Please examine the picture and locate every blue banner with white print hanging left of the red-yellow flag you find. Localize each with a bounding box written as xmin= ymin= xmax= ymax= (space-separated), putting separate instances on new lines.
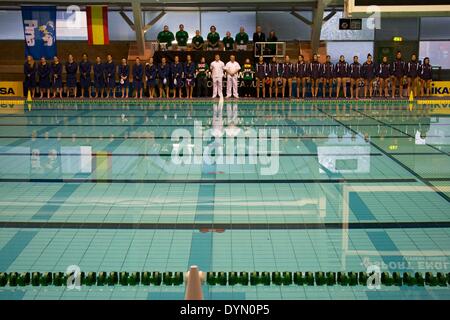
xmin=22 ymin=6 xmax=56 ymax=59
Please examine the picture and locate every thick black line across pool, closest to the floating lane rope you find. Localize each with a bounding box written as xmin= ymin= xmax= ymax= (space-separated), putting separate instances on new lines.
xmin=0 ymin=221 xmax=450 ymax=231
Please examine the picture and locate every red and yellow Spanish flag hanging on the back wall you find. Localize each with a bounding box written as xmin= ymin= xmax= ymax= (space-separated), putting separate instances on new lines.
xmin=86 ymin=6 xmax=109 ymax=45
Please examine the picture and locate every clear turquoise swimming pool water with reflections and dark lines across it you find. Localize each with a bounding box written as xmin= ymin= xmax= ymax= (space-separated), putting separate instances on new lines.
xmin=0 ymin=100 xmax=450 ymax=299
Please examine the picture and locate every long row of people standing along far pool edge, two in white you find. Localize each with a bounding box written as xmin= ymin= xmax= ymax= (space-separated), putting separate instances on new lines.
xmin=24 ymin=51 xmax=432 ymax=99
